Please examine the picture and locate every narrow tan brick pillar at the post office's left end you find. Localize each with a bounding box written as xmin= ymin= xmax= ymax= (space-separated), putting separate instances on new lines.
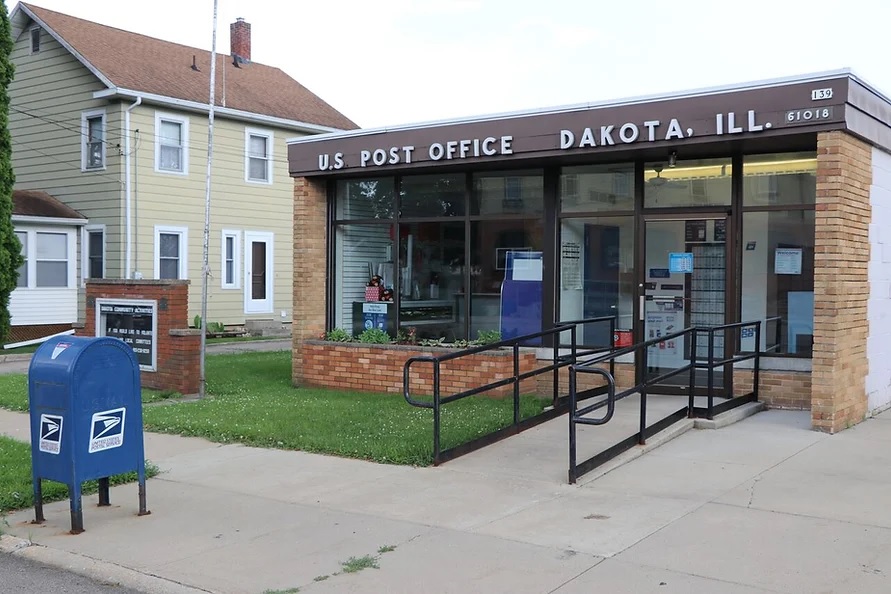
xmin=291 ymin=178 xmax=328 ymax=386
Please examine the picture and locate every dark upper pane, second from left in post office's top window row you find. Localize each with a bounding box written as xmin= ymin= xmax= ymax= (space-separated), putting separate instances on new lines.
xmin=399 ymin=173 xmax=467 ymax=218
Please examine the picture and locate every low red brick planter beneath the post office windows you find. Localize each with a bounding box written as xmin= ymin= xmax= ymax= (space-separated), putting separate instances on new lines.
xmin=302 ymin=340 xmax=538 ymax=396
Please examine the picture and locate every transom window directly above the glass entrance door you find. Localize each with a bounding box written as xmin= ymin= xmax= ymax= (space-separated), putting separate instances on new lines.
xmin=644 ymin=159 xmax=732 ymax=208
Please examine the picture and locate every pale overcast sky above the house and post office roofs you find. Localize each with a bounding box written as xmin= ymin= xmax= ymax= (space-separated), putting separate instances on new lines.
xmin=12 ymin=0 xmax=891 ymax=128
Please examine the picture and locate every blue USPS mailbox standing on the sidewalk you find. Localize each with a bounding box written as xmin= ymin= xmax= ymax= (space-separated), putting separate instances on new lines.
xmin=28 ymin=336 xmax=149 ymax=534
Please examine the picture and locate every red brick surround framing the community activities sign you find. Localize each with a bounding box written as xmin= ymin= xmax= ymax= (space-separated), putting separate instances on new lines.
xmin=77 ymin=279 xmax=201 ymax=394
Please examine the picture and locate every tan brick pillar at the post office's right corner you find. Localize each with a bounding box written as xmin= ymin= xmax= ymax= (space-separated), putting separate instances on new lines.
xmin=811 ymin=131 xmax=872 ymax=433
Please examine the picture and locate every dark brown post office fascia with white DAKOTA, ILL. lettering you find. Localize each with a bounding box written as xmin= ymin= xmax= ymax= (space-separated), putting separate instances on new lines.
xmin=288 ymin=69 xmax=891 ymax=177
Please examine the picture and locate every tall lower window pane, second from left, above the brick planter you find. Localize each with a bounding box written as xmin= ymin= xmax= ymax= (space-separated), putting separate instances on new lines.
xmin=398 ymin=221 xmax=465 ymax=342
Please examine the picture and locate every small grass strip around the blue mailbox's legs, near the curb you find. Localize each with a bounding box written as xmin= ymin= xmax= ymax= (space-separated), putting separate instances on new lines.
xmin=0 ymin=435 xmax=158 ymax=516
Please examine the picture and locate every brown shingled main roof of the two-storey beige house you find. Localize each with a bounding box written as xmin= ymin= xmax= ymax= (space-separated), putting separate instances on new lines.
xmin=19 ymin=3 xmax=358 ymax=130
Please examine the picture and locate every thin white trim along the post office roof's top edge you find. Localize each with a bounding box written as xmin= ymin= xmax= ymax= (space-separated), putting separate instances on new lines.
xmin=290 ymin=68 xmax=863 ymax=145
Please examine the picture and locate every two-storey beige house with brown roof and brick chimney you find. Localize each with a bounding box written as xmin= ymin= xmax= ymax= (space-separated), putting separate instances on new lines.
xmin=9 ymin=3 xmax=356 ymax=338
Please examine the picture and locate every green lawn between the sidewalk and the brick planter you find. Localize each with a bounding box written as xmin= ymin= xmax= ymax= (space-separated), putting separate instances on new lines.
xmin=0 ymin=351 xmax=550 ymax=465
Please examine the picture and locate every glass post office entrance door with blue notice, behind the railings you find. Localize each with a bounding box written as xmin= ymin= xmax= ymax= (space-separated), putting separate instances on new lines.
xmin=638 ymin=215 xmax=733 ymax=393
